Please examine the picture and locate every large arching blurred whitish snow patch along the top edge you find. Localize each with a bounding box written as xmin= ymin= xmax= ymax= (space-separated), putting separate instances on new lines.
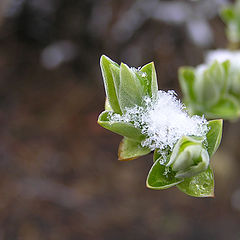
xmin=112 ymin=0 xmax=229 ymax=47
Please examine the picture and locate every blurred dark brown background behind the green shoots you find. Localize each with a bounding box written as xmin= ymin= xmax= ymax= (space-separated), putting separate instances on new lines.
xmin=0 ymin=0 xmax=240 ymax=240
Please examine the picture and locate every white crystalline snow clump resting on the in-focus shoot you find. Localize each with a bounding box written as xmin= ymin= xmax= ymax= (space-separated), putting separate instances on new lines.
xmin=109 ymin=91 xmax=208 ymax=150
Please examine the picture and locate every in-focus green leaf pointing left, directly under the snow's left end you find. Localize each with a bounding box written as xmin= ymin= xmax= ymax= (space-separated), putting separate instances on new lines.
xmin=98 ymin=111 xmax=145 ymax=142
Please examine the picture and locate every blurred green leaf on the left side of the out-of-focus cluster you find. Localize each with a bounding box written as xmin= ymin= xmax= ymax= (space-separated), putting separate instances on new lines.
xmin=178 ymin=67 xmax=196 ymax=102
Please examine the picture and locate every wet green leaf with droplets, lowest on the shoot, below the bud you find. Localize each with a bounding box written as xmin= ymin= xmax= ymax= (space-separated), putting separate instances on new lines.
xmin=177 ymin=167 xmax=214 ymax=197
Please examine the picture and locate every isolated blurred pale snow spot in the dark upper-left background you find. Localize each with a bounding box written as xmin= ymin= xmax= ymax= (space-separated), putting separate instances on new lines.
xmin=40 ymin=40 xmax=77 ymax=69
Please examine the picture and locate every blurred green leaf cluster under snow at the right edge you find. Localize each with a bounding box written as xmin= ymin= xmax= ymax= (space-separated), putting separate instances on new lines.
xmin=178 ymin=61 xmax=240 ymax=119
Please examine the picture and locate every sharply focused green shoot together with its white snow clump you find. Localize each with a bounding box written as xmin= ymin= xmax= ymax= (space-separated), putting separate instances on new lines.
xmin=98 ymin=56 xmax=222 ymax=197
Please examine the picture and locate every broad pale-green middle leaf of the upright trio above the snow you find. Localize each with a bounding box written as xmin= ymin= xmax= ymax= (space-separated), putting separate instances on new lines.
xmin=119 ymin=63 xmax=144 ymax=112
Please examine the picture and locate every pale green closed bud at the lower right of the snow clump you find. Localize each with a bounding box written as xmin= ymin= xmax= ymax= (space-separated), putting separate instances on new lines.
xmin=166 ymin=136 xmax=209 ymax=178
